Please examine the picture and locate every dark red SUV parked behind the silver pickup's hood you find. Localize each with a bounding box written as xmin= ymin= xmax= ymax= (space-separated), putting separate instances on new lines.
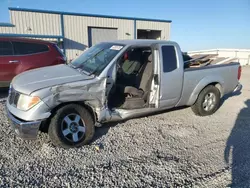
xmin=0 ymin=37 xmax=66 ymax=87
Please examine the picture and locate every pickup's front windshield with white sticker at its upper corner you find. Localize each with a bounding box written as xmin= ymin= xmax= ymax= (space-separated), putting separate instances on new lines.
xmin=71 ymin=43 xmax=124 ymax=75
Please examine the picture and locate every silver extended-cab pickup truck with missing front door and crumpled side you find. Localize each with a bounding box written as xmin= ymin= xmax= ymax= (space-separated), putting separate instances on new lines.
xmin=6 ymin=40 xmax=241 ymax=148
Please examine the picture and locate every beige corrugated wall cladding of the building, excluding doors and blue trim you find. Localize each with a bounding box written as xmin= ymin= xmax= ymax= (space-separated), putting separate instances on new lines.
xmin=0 ymin=10 xmax=170 ymax=59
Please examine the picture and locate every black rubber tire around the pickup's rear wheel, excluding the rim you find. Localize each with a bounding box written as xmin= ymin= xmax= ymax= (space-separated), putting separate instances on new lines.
xmin=191 ymin=85 xmax=220 ymax=116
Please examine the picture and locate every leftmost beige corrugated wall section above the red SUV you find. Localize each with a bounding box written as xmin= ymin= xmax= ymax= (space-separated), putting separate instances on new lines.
xmin=0 ymin=11 xmax=61 ymax=35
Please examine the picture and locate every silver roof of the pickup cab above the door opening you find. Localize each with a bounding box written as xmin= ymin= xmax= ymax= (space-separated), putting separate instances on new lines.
xmin=109 ymin=39 xmax=177 ymax=45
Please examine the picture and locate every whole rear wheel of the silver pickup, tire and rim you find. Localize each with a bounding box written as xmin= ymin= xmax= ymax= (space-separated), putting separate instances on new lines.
xmin=191 ymin=85 xmax=220 ymax=116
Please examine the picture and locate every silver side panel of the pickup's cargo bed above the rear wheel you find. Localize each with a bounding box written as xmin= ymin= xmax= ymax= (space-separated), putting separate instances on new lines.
xmin=177 ymin=64 xmax=239 ymax=106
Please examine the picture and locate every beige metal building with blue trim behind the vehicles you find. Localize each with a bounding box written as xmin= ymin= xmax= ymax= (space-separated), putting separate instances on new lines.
xmin=0 ymin=8 xmax=171 ymax=59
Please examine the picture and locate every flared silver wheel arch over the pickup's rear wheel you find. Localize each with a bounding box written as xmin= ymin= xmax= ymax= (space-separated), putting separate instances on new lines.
xmin=187 ymin=76 xmax=224 ymax=106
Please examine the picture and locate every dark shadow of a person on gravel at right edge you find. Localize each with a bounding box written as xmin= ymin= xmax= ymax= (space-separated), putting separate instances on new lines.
xmin=224 ymin=99 xmax=250 ymax=187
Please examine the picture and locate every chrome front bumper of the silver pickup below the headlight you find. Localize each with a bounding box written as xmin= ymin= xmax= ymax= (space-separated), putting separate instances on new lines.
xmin=6 ymin=109 xmax=42 ymax=140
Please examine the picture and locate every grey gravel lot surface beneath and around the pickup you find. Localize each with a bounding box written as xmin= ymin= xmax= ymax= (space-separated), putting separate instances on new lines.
xmin=0 ymin=67 xmax=250 ymax=187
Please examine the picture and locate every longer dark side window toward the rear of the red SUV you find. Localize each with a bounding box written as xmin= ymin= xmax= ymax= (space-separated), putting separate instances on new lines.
xmin=12 ymin=41 xmax=49 ymax=55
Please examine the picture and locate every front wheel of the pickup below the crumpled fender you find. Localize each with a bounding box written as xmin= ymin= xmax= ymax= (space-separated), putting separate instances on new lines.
xmin=48 ymin=104 xmax=95 ymax=148
